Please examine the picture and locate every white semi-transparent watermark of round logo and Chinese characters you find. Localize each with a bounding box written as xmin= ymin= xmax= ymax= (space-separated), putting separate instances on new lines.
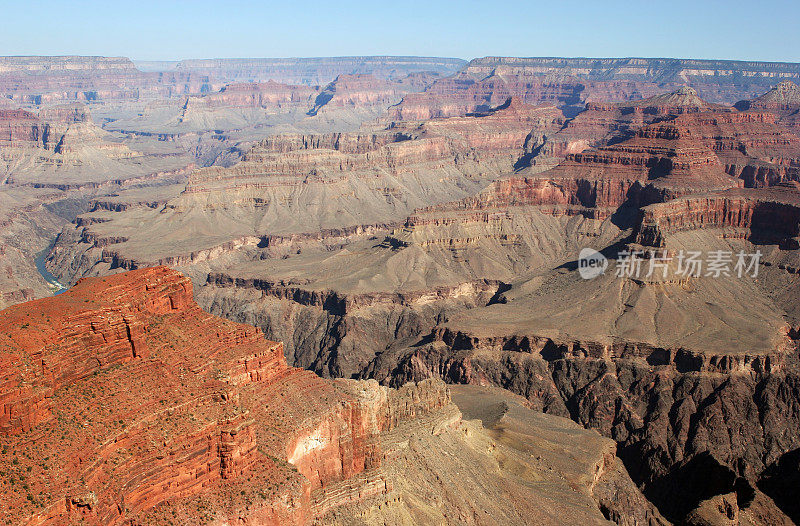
xmin=578 ymin=248 xmax=762 ymax=279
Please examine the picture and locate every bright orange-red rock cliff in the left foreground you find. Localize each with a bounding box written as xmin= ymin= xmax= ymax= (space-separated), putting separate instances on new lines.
xmin=0 ymin=267 xmax=449 ymax=524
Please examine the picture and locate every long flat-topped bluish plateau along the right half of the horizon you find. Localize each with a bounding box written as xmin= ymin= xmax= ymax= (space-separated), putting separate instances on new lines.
xmin=392 ymin=57 xmax=800 ymax=119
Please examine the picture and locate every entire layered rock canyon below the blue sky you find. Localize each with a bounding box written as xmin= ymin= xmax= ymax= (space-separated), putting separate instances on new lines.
xmin=0 ymin=52 xmax=800 ymax=525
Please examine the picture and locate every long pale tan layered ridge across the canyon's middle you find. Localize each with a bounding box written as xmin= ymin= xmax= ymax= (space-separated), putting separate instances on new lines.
xmin=48 ymin=97 xmax=561 ymax=274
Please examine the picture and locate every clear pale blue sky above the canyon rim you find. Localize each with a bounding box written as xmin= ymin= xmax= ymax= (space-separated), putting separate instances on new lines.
xmin=0 ymin=0 xmax=800 ymax=62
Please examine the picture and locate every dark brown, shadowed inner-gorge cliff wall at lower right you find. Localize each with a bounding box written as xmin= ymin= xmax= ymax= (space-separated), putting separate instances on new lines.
xmin=376 ymin=332 xmax=800 ymax=524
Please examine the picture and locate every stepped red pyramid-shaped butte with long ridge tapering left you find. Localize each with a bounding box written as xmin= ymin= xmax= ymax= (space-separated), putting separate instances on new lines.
xmin=409 ymin=113 xmax=741 ymax=224
